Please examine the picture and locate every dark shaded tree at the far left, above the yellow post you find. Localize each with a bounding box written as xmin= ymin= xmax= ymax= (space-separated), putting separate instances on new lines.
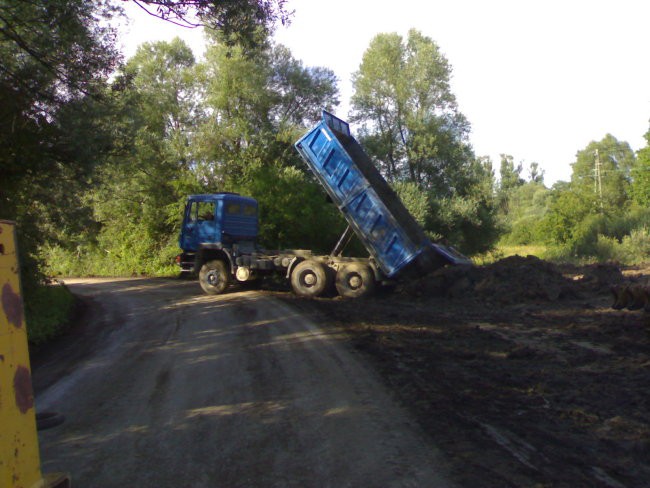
xmin=0 ymin=0 xmax=119 ymax=285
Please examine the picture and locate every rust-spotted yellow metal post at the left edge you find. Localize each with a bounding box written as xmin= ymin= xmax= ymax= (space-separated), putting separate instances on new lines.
xmin=0 ymin=220 xmax=69 ymax=488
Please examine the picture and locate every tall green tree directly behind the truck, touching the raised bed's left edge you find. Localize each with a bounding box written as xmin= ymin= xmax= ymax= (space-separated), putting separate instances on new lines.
xmin=195 ymin=36 xmax=340 ymax=249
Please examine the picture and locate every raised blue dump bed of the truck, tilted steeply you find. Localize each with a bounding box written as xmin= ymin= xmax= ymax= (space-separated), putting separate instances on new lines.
xmin=296 ymin=111 xmax=470 ymax=278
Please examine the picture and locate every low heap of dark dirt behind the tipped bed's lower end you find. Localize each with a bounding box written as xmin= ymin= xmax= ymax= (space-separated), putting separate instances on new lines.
xmin=398 ymin=256 xmax=622 ymax=304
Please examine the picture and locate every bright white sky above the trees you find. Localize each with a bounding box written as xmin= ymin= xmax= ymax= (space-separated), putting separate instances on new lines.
xmin=122 ymin=0 xmax=650 ymax=185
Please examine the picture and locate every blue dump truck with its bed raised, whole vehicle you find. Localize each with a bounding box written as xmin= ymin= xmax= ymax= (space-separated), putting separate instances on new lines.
xmin=176 ymin=111 xmax=470 ymax=297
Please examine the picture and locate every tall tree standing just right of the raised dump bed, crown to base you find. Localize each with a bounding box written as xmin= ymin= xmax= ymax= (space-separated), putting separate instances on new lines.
xmin=351 ymin=30 xmax=496 ymax=252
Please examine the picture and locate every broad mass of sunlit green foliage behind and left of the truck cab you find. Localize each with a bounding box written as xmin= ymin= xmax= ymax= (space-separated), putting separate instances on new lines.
xmin=48 ymin=34 xmax=340 ymax=274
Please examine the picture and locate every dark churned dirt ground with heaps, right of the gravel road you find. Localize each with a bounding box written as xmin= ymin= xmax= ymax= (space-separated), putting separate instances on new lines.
xmin=274 ymin=256 xmax=650 ymax=488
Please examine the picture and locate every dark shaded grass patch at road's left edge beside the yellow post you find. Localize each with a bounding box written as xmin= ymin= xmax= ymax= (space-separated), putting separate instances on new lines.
xmin=24 ymin=283 xmax=75 ymax=345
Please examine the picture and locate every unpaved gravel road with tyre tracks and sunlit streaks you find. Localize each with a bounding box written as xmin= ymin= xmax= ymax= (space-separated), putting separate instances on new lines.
xmin=32 ymin=279 xmax=450 ymax=488
